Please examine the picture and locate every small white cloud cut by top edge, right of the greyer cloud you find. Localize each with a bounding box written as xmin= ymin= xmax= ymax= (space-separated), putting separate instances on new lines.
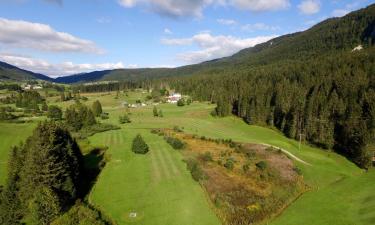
xmin=229 ymin=0 xmax=290 ymax=11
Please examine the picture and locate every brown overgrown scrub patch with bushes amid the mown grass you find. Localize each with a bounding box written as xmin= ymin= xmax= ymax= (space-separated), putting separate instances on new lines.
xmin=157 ymin=129 xmax=305 ymax=225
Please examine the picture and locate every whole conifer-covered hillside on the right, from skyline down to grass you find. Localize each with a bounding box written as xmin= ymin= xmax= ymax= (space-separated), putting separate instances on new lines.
xmin=160 ymin=5 xmax=375 ymax=168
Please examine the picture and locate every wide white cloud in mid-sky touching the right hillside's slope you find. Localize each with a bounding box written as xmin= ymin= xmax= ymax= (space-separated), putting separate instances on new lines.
xmin=162 ymin=33 xmax=277 ymax=63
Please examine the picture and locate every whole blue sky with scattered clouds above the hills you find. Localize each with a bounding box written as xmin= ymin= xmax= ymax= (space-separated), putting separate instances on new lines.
xmin=0 ymin=0 xmax=374 ymax=76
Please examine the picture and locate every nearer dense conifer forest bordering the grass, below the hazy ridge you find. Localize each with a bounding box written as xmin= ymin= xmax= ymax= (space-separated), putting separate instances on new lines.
xmin=167 ymin=47 xmax=375 ymax=168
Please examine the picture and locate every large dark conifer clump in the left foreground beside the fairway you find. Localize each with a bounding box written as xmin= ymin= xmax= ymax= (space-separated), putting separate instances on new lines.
xmin=0 ymin=121 xmax=83 ymax=224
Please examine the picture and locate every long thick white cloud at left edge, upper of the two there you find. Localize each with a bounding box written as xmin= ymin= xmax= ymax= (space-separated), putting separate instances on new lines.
xmin=0 ymin=18 xmax=103 ymax=54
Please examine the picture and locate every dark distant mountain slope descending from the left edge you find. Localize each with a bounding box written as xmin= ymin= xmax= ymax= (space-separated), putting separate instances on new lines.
xmin=0 ymin=62 xmax=54 ymax=81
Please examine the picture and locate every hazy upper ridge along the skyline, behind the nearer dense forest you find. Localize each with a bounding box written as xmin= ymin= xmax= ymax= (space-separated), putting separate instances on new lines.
xmin=58 ymin=4 xmax=375 ymax=83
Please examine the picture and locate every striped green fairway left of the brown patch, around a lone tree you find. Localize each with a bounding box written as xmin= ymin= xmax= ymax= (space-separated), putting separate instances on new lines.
xmin=90 ymin=129 xmax=220 ymax=225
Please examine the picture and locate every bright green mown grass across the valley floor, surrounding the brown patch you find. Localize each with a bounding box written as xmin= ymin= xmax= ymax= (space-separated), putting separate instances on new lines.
xmin=0 ymin=92 xmax=375 ymax=225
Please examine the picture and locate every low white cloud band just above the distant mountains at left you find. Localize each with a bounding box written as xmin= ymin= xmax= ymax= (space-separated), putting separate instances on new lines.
xmin=0 ymin=53 xmax=126 ymax=77
